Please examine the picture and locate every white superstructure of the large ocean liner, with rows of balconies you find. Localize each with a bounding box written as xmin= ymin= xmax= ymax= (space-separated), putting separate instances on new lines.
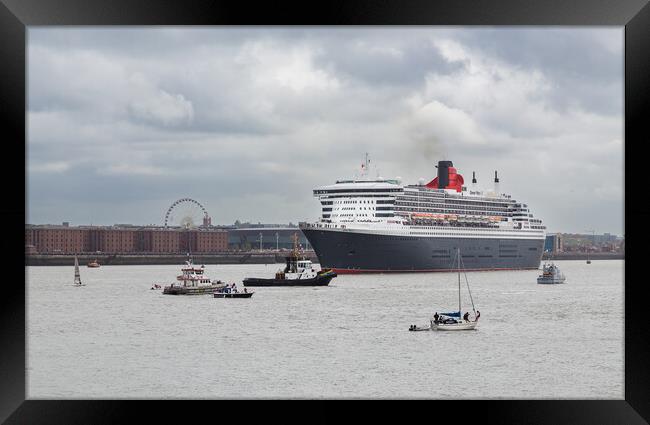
xmin=304 ymin=176 xmax=546 ymax=238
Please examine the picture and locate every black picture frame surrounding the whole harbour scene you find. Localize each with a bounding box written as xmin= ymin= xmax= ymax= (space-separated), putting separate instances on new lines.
xmin=0 ymin=0 xmax=650 ymax=424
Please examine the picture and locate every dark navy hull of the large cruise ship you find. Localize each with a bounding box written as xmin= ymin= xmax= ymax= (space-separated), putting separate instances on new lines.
xmin=302 ymin=228 xmax=544 ymax=273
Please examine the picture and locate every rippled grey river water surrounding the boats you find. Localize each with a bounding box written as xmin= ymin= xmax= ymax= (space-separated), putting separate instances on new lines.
xmin=26 ymin=260 xmax=624 ymax=399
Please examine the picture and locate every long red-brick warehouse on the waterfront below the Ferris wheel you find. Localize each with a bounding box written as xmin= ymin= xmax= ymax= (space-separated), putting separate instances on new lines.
xmin=25 ymin=223 xmax=228 ymax=254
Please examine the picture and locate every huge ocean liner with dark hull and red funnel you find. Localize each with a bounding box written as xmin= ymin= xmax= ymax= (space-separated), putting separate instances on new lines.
xmin=300 ymin=157 xmax=546 ymax=273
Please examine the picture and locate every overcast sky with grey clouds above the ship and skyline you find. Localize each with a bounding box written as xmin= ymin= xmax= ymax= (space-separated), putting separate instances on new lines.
xmin=26 ymin=27 xmax=624 ymax=235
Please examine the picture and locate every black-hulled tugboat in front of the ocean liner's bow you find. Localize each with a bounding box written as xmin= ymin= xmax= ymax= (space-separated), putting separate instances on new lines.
xmin=243 ymin=233 xmax=336 ymax=286
